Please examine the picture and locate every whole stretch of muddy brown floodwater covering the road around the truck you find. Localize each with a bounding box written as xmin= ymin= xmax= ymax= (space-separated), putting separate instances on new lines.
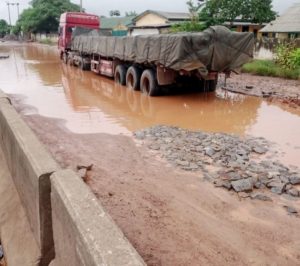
xmin=0 ymin=43 xmax=300 ymax=166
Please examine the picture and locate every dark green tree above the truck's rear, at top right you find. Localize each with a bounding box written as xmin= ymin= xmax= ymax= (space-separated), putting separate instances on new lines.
xmin=199 ymin=0 xmax=276 ymax=26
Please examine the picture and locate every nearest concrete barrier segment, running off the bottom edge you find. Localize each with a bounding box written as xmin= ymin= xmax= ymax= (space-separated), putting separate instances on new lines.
xmin=51 ymin=170 xmax=145 ymax=266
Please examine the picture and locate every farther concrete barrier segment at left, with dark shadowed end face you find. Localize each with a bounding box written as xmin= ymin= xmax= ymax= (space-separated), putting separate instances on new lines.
xmin=0 ymin=94 xmax=59 ymax=265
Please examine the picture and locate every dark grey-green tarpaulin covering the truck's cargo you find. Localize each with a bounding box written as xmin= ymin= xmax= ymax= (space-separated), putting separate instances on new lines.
xmin=71 ymin=26 xmax=254 ymax=72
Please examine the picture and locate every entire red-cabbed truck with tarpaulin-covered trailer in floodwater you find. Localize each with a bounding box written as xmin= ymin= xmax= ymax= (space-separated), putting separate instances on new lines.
xmin=58 ymin=12 xmax=254 ymax=96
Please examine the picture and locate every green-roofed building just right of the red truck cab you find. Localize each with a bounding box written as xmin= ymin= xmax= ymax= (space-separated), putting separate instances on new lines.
xmin=100 ymin=16 xmax=135 ymax=36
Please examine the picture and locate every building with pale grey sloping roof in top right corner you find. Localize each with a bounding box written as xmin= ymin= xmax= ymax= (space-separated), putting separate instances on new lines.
xmin=260 ymin=3 xmax=300 ymax=39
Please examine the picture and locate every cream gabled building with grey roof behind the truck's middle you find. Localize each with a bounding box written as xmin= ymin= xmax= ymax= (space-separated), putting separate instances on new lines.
xmin=129 ymin=10 xmax=191 ymax=36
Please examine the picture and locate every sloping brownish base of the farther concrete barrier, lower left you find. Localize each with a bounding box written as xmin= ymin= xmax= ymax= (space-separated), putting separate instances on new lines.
xmin=0 ymin=144 xmax=41 ymax=266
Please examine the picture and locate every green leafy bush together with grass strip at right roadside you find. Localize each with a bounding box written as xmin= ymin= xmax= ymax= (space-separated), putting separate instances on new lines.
xmin=242 ymin=44 xmax=300 ymax=80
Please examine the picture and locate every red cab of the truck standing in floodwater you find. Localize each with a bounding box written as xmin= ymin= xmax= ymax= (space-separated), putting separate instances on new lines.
xmin=58 ymin=12 xmax=100 ymax=58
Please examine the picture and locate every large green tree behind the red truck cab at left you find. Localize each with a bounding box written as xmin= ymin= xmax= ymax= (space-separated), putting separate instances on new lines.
xmin=17 ymin=0 xmax=80 ymax=32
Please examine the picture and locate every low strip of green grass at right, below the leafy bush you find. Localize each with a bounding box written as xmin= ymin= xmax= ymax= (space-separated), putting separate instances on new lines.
xmin=242 ymin=60 xmax=300 ymax=79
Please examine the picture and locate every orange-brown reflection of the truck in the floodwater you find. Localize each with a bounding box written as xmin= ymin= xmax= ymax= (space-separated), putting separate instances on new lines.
xmin=62 ymin=65 xmax=261 ymax=134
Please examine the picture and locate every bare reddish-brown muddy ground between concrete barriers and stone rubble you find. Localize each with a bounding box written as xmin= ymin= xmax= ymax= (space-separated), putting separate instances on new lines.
xmin=11 ymin=92 xmax=300 ymax=266
